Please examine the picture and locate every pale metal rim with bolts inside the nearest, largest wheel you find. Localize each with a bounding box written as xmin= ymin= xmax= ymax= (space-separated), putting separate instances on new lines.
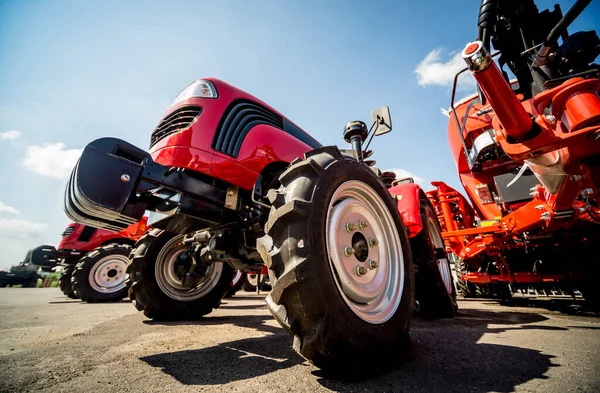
xmin=325 ymin=180 xmax=404 ymax=324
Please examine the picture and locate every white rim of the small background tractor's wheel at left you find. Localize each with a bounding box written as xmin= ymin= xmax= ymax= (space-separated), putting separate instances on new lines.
xmin=88 ymin=255 xmax=129 ymax=293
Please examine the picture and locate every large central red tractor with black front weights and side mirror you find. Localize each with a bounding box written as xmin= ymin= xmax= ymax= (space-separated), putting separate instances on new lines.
xmin=65 ymin=78 xmax=456 ymax=367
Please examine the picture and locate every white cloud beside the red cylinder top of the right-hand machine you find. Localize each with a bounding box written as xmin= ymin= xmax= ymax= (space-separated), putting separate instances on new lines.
xmin=415 ymin=48 xmax=476 ymax=90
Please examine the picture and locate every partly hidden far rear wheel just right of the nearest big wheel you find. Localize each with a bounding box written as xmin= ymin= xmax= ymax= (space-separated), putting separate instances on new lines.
xmin=410 ymin=199 xmax=458 ymax=318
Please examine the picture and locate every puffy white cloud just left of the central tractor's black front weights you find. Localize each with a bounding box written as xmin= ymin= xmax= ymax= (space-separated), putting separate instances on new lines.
xmin=23 ymin=143 xmax=83 ymax=179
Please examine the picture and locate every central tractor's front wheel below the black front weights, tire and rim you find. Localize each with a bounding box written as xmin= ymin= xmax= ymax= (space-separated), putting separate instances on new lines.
xmin=127 ymin=229 xmax=233 ymax=321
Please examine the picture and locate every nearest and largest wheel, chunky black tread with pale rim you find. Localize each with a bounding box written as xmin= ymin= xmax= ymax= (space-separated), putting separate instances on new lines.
xmin=258 ymin=147 xmax=414 ymax=374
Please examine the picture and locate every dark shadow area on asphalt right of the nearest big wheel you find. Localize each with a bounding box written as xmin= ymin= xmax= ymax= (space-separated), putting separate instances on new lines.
xmin=313 ymin=309 xmax=568 ymax=392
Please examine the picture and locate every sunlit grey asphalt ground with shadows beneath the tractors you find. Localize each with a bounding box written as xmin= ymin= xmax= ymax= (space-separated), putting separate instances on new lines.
xmin=0 ymin=288 xmax=600 ymax=393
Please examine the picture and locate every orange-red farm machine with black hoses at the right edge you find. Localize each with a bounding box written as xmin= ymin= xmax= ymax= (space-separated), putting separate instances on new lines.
xmin=428 ymin=0 xmax=600 ymax=306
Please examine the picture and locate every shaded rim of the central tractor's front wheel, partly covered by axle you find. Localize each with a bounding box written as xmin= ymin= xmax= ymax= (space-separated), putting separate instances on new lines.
xmin=154 ymin=235 xmax=223 ymax=302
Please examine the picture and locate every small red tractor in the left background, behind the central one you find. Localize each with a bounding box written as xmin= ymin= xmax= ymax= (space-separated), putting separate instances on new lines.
xmin=27 ymin=217 xmax=147 ymax=303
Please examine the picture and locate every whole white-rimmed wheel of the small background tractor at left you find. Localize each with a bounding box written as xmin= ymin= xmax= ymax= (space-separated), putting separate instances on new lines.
xmin=71 ymin=244 xmax=131 ymax=303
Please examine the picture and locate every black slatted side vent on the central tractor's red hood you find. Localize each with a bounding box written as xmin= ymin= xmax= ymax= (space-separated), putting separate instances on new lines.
xmin=213 ymin=100 xmax=283 ymax=157
